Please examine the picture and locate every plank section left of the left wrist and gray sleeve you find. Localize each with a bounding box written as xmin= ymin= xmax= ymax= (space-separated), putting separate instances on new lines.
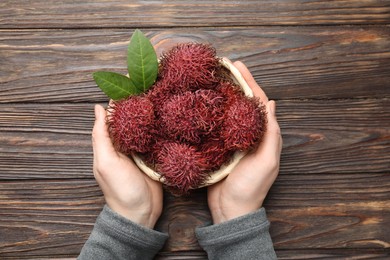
xmin=0 ymin=180 xmax=103 ymax=258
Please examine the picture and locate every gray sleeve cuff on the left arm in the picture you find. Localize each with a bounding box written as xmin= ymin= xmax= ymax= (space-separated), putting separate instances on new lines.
xmin=77 ymin=205 xmax=168 ymax=260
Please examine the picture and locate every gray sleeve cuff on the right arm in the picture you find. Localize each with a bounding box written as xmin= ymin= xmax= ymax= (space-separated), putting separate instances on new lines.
xmin=195 ymin=208 xmax=277 ymax=260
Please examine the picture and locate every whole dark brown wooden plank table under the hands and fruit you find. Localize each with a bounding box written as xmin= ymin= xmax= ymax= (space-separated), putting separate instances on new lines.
xmin=0 ymin=0 xmax=390 ymax=259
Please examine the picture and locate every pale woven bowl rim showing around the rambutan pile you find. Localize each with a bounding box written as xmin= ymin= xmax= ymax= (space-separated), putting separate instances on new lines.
xmin=131 ymin=58 xmax=254 ymax=188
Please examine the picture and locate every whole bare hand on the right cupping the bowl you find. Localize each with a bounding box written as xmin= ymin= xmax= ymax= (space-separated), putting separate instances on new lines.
xmin=208 ymin=62 xmax=282 ymax=224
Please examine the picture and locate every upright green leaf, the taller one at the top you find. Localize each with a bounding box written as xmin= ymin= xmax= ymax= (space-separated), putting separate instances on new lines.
xmin=127 ymin=29 xmax=158 ymax=92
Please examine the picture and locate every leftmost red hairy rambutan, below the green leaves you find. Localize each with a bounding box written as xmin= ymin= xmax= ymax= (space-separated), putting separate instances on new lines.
xmin=108 ymin=95 xmax=155 ymax=154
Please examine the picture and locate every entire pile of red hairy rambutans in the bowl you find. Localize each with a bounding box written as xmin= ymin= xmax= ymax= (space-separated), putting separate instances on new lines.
xmin=108 ymin=43 xmax=266 ymax=194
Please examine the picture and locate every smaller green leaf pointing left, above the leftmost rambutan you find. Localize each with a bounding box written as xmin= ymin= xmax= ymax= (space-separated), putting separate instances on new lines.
xmin=93 ymin=71 xmax=140 ymax=100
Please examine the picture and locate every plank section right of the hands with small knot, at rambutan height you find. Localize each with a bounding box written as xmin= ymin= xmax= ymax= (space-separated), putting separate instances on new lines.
xmin=277 ymin=99 xmax=390 ymax=174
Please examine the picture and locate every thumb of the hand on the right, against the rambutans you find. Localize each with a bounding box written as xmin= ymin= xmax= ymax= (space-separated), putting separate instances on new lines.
xmin=256 ymin=100 xmax=282 ymax=158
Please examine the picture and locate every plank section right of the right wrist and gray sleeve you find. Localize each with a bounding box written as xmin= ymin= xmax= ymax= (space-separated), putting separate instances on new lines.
xmin=264 ymin=172 xmax=390 ymax=249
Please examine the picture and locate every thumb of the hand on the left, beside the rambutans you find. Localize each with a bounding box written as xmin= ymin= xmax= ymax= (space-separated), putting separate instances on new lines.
xmin=92 ymin=105 xmax=115 ymax=158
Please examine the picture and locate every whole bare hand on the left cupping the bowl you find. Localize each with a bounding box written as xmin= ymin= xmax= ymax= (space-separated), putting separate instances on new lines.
xmin=92 ymin=105 xmax=163 ymax=228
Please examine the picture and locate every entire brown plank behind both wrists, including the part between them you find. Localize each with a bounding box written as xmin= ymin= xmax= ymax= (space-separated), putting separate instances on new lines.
xmin=0 ymin=173 xmax=390 ymax=259
